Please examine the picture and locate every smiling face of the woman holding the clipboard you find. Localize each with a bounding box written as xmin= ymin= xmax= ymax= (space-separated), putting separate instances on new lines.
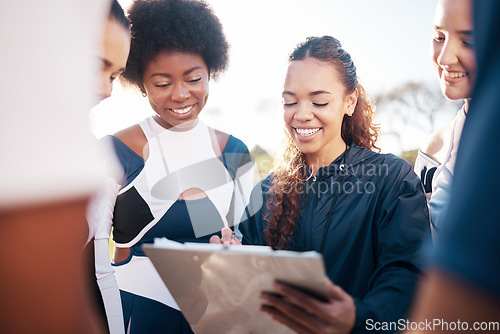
xmin=283 ymin=58 xmax=357 ymax=167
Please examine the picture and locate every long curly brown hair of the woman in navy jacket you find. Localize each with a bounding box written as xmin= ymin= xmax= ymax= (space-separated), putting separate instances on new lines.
xmin=264 ymin=36 xmax=379 ymax=249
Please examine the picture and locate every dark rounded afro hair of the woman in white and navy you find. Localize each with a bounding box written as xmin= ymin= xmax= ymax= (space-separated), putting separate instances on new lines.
xmin=121 ymin=0 xmax=229 ymax=89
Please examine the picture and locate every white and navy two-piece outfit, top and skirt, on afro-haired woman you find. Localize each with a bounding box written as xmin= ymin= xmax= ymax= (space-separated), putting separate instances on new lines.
xmin=102 ymin=117 xmax=254 ymax=333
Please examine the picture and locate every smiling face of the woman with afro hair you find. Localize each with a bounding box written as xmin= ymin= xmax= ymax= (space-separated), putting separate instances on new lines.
xmin=141 ymin=51 xmax=209 ymax=129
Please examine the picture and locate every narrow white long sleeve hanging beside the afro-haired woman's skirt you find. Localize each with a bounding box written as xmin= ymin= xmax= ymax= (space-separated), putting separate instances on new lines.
xmin=88 ymin=177 xmax=125 ymax=334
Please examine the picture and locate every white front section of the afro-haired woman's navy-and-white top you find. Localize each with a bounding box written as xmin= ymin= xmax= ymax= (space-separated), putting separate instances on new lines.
xmin=116 ymin=117 xmax=234 ymax=247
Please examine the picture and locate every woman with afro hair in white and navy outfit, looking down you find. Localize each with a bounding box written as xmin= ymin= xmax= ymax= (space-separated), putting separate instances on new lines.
xmin=95 ymin=0 xmax=253 ymax=334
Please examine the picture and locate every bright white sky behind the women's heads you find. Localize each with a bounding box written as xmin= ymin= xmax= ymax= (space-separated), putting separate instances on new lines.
xmin=91 ymin=0 xmax=444 ymax=154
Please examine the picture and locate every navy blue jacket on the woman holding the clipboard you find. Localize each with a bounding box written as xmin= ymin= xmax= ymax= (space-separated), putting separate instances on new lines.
xmin=240 ymin=145 xmax=430 ymax=333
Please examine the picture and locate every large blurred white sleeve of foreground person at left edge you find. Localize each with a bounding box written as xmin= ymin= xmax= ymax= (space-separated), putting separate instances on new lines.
xmin=0 ymin=0 xmax=109 ymax=208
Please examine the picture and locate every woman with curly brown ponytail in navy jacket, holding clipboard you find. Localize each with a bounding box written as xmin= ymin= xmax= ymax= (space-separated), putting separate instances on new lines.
xmin=236 ymin=36 xmax=430 ymax=333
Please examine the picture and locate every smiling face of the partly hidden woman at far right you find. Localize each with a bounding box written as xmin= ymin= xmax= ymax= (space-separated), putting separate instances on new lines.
xmin=432 ymin=0 xmax=477 ymax=100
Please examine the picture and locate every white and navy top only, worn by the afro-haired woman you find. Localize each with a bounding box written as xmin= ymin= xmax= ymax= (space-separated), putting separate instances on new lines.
xmin=111 ymin=117 xmax=253 ymax=254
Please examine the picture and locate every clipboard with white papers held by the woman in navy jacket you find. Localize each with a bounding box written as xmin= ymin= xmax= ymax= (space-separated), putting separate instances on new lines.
xmin=143 ymin=238 xmax=328 ymax=334
